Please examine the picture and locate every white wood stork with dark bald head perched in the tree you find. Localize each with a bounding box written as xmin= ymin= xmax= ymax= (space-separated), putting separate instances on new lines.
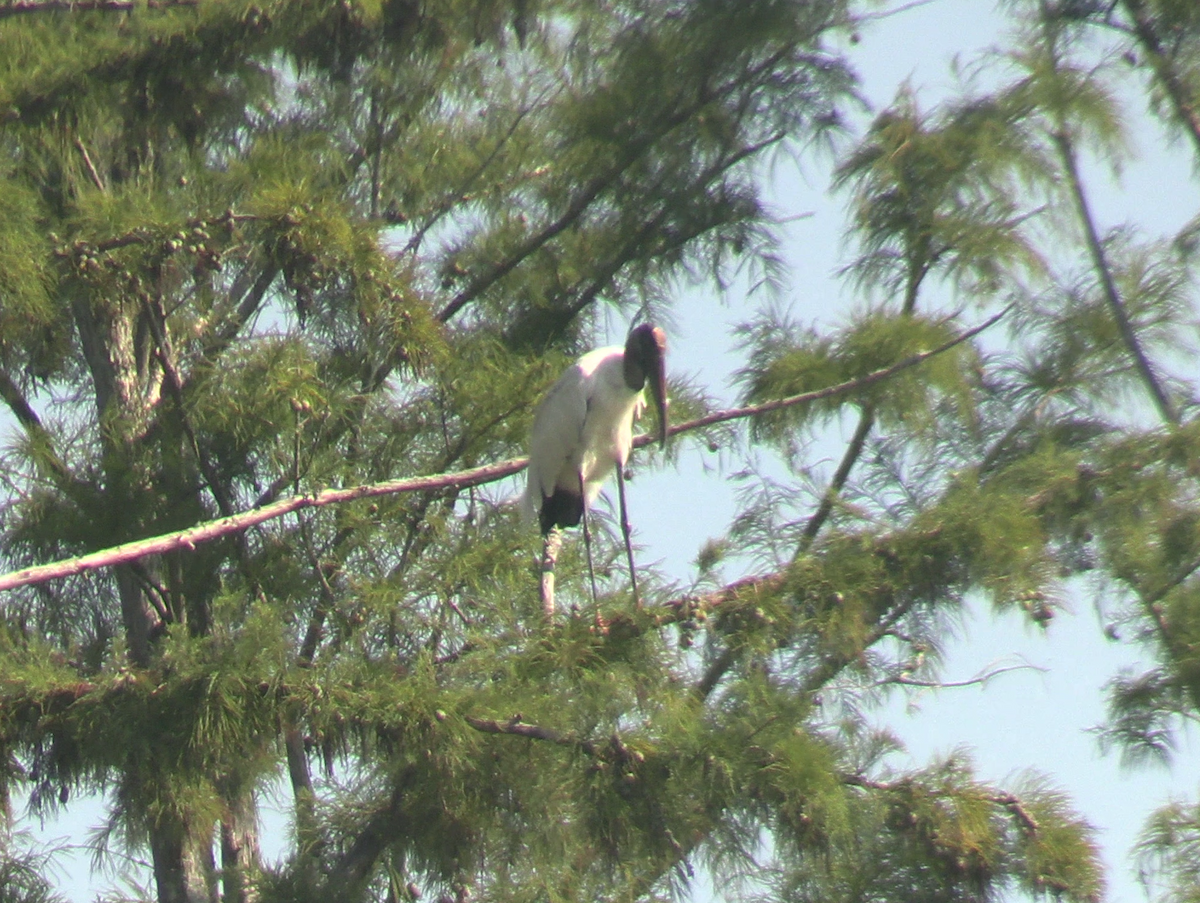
xmin=524 ymin=323 xmax=667 ymax=614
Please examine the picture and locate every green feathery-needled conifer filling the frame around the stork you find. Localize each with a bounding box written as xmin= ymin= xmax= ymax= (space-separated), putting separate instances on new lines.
xmin=0 ymin=0 xmax=1200 ymax=903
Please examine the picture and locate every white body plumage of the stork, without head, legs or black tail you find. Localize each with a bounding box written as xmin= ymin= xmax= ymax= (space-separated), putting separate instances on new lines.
xmin=523 ymin=346 xmax=646 ymax=518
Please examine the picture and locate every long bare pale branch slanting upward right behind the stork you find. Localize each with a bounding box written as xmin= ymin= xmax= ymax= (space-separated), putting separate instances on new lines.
xmin=0 ymin=307 xmax=1010 ymax=590
